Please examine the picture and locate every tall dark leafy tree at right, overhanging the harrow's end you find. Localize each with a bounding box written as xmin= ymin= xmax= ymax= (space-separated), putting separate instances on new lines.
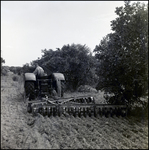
xmin=94 ymin=1 xmax=148 ymax=103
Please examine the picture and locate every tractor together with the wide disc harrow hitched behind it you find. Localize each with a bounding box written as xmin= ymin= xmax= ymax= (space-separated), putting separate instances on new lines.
xmin=24 ymin=73 xmax=127 ymax=117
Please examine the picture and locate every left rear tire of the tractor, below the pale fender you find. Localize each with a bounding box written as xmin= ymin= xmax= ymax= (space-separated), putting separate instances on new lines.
xmin=25 ymin=82 xmax=35 ymax=100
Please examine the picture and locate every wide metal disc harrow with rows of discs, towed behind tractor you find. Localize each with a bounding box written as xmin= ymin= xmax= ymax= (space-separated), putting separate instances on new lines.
xmin=27 ymin=97 xmax=127 ymax=117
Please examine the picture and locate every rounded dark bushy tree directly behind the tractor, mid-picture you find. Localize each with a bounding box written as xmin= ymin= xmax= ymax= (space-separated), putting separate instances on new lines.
xmin=32 ymin=44 xmax=97 ymax=90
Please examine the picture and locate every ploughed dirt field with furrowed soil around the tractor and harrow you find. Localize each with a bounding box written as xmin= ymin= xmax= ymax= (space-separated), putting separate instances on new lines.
xmin=1 ymin=74 xmax=148 ymax=149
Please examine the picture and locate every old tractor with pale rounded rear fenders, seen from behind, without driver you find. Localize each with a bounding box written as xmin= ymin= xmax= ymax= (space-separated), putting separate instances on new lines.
xmin=24 ymin=73 xmax=65 ymax=100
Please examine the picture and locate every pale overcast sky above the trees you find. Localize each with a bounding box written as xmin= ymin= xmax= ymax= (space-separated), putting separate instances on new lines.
xmin=1 ymin=1 xmax=147 ymax=66
